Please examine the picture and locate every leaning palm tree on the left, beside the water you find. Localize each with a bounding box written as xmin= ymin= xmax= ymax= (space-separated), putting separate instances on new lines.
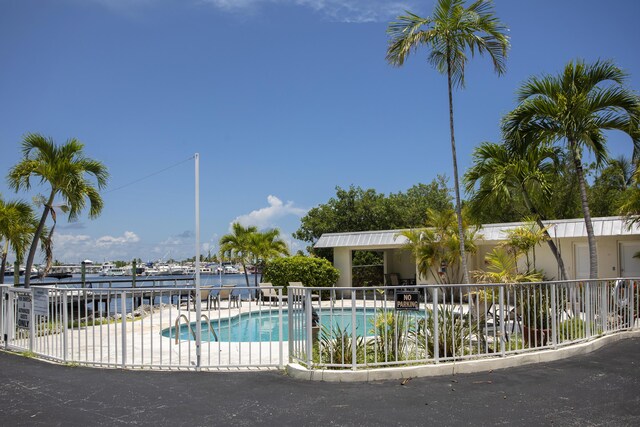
xmin=8 ymin=133 xmax=109 ymax=288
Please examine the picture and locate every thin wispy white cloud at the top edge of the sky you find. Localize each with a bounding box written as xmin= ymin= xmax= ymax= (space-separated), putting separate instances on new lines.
xmin=201 ymin=0 xmax=417 ymax=22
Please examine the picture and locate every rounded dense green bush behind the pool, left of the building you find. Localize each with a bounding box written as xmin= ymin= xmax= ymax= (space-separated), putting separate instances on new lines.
xmin=262 ymin=255 xmax=340 ymax=293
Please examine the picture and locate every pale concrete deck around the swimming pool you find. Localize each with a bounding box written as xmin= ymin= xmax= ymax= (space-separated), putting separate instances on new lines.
xmin=34 ymin=300 xmax=416 ymax=369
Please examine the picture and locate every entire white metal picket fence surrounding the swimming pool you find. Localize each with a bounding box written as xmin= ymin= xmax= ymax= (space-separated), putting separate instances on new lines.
xmin=0 ymin=279 xmax=640 ymax=369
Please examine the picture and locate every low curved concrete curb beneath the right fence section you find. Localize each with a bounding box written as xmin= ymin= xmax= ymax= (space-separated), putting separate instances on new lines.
xmin=286 ymin=331 xmax=640 ymax=382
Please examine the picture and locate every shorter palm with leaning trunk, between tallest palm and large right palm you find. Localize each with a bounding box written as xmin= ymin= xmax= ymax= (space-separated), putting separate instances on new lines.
xmin=464 ymin=142 xmax=568 ymax=280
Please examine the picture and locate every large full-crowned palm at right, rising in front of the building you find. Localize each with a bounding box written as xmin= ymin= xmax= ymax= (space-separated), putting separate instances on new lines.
xmin=503 ymin=61 xmax=640 ymax=279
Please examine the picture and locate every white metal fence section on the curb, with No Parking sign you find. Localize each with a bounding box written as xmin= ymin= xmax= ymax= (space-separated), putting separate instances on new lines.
xmin=289 ymin=279 xmax=640 ymax=369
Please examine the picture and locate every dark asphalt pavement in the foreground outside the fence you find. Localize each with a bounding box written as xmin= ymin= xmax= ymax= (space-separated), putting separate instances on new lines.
xmin=0 ymin=338 xmax=640 ymax=426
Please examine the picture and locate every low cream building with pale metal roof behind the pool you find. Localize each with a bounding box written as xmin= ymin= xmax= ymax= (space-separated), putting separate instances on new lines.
xmin=314 ymin=217 xmax=640 ymax=287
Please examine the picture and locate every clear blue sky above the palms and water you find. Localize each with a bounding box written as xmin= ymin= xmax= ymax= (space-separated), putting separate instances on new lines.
xmin=0 ymin=0 xmax=640 ymax=263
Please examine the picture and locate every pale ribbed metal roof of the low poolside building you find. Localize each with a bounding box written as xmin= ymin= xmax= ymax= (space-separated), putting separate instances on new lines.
xmin=314 ymin=217 xmax=640 ymax=249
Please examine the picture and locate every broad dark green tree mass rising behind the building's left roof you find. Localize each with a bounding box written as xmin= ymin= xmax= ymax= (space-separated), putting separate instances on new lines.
xmin=293 ymin=176 xmax=451 ymax=258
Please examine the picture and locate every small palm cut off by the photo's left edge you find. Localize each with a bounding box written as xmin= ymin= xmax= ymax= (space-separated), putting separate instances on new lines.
xmin=0 ymin=198 xmax=38 ymax=284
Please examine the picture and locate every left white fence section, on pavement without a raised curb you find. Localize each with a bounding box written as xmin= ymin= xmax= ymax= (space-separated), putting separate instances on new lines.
xmin=0 ymin=286 xmax=285 ymax=369
